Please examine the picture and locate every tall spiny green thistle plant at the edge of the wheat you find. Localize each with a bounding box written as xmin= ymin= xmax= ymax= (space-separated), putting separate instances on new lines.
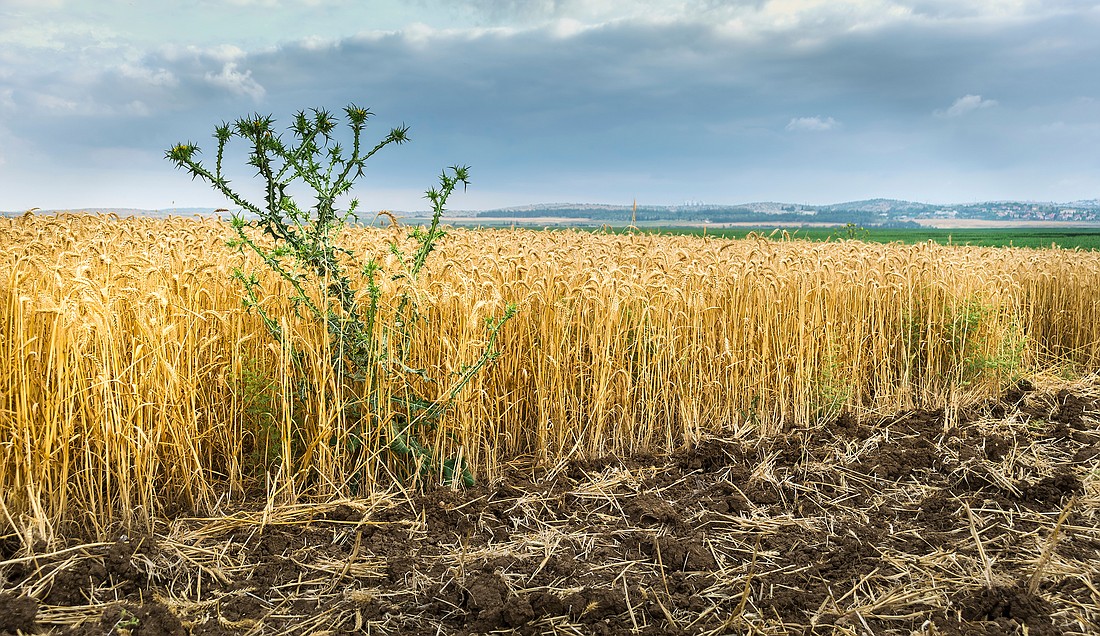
xmin=165 ymin=105 xmax=516 ymax=485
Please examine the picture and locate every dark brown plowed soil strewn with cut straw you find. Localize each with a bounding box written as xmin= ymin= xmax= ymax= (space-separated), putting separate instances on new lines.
xmin=0 ymin=374 xmax=1100 ymax=636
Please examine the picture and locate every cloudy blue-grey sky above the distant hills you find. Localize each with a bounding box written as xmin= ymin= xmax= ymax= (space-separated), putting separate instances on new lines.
xmin=0 ymin=0 xmax=1100 ymax=210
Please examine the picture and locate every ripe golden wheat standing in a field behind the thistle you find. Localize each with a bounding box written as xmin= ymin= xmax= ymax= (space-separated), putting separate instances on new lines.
xmin=0 ymin=215 xmax=1100 ymax=545
